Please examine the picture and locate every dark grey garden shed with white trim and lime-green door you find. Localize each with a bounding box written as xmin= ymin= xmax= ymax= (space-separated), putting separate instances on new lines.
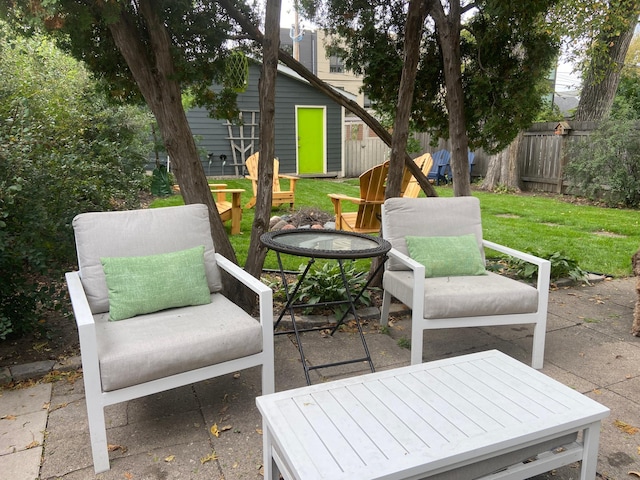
xmin=187 ymin=60 xmax=355 ymax=176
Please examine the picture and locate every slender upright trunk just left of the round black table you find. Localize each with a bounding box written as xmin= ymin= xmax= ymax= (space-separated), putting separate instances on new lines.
xmin=245 ymin=0 xmax=280 ymax=278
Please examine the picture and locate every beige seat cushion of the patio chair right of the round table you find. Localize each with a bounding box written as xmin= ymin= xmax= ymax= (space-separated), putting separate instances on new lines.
xmin=383 ymin=270 xmax=538 ymax=319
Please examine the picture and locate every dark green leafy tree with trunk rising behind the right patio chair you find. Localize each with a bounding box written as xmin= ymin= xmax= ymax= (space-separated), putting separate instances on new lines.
xmin=302 ymin=0 xmax=558 ymax=195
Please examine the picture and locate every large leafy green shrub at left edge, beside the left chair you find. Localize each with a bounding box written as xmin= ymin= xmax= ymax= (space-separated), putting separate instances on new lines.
xmin=0 ymin=23 xmax=151 ymax=339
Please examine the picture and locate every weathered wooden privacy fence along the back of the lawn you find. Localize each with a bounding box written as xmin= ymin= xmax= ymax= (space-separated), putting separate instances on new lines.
xmin=344 ymin=119 xmax=596 ymax=193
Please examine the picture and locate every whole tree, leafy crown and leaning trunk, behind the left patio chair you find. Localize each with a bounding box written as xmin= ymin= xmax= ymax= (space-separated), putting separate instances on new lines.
xmin=0 ymin=0 xmax=260 ymax=261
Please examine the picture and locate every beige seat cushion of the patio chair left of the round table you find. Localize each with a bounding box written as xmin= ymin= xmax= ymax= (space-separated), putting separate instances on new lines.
xmin=94 ymin=293 xmax=262 ymax=391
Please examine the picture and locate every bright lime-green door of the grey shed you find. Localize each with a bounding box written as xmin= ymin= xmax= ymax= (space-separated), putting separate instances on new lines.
xmin=296 ymin=107 xmax=326 ymax=174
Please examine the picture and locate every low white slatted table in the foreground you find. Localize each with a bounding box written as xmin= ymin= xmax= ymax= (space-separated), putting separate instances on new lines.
xmin=256 ymin=350 xmax=609 ymax=480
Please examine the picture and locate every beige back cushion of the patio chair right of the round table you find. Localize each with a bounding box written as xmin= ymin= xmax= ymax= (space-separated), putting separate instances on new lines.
xmin=382 ymin=197 xmax=485 ymax=270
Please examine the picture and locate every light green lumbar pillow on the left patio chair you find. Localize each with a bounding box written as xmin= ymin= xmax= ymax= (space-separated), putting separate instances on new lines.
xmin=100 ymin=245 xmax=211 ymax=321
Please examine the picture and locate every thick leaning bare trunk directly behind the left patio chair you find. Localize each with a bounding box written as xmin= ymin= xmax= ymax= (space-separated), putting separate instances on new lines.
xmin=109 ymin=0 xmax=237 ymax=263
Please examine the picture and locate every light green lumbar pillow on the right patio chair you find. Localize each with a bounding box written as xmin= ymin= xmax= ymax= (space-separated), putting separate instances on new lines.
xmin=405 ymin=233 xmax=487 ymax=278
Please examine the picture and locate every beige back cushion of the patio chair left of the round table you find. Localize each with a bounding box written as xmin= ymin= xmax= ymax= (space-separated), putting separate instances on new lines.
xmin=73 ymin=204 xmax=222 ymax=314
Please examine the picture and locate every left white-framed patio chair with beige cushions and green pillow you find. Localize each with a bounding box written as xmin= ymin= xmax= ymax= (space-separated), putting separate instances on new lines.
xmin=66 ymin=204 xmax=275 ymax=473
